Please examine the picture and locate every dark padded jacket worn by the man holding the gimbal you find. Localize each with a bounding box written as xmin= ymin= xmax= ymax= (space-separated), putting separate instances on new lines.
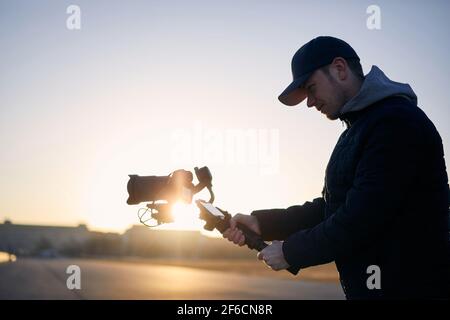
xmin=252 ymin=97 xmax=450 ymax=299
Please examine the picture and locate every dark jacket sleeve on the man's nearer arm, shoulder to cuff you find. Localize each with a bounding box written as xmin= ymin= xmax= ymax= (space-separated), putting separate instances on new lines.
xmin=283 ymin=119 xmax=422 ymax=268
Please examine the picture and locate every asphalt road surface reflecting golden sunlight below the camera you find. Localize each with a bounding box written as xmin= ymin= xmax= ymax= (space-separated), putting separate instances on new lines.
xmin=0 ymin=259 xmax=344 ymax=300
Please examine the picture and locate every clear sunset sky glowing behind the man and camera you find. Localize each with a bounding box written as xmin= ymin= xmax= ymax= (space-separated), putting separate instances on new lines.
xmin=0 ymin=0 xmax=450 ymax=232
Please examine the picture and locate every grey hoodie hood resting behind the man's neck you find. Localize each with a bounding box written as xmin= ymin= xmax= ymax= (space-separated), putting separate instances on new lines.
xmin=340 ymin=66 xmax=417 ymax=115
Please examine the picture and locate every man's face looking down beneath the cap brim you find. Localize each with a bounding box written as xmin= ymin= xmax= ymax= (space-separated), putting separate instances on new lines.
xmin=303 ymin=69 xmax=346 ymax=120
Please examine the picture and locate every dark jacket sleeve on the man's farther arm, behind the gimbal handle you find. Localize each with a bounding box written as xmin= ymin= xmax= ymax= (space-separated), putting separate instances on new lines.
xmin=251 ymin=198 xmax=325 ymax=241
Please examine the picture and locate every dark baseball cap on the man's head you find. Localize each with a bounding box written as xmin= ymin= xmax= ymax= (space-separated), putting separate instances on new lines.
xmin=278 ymin=36 xmax=359 ymax=106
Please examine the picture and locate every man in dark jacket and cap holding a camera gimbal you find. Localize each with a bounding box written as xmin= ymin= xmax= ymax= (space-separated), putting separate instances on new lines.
xmin=224 ymin=37 xmax=450 ymax=299
